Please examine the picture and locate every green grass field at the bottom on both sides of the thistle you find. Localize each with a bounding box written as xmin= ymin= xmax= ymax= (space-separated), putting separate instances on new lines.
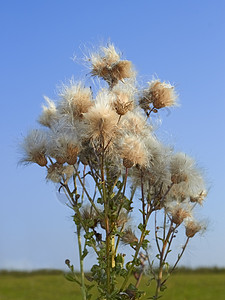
xmin=0 ymin=270 xmax=225 ymax=300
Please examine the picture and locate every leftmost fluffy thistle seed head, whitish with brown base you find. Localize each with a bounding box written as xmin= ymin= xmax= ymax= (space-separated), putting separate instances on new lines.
xmin=21 ymin=129 xmax=47 ymax=167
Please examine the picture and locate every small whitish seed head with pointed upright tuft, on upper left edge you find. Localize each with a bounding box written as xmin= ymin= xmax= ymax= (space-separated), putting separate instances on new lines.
xmin=38 ymin=96 xmax=58 ymax=127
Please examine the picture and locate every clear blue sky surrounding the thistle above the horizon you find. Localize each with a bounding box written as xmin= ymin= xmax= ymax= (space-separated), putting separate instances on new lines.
xmin=0 ymin=0 xmax=225 ymax=269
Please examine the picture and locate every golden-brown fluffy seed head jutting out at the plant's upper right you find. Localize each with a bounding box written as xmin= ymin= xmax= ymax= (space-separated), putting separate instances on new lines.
xmin=139 ymin=80 xmax=177 ymax=111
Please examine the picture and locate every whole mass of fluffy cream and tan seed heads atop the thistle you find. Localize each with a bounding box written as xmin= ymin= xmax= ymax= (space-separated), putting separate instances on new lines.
xmin=21 ymin=45 xmax=206 ymax=237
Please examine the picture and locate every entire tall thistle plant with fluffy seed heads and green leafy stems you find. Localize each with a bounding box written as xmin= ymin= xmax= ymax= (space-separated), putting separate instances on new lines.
xmin=21 ymin=44 xmax=206 ymax=300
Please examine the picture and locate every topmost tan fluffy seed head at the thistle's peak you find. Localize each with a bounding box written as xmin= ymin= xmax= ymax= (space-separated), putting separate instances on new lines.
xmin=90 ymin=44 xmax=133 ymax=88
